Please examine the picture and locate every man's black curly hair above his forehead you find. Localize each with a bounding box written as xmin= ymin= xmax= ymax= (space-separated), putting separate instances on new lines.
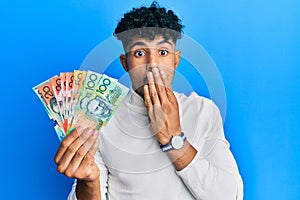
xmin=114 ymin=1 xmax=184 ymax=47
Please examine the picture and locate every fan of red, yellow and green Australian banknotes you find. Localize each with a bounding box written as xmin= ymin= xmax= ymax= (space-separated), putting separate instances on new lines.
xmin=32 ymin=70 xmax=129 ymax=141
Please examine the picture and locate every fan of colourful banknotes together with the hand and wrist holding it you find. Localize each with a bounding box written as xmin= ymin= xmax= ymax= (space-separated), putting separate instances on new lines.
xmin=32 ymin=70 xmax=129 ymax=199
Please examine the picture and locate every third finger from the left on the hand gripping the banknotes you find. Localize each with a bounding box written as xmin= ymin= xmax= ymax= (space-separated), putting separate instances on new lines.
xmin=65 ymin=130 xmax=99 ymax=177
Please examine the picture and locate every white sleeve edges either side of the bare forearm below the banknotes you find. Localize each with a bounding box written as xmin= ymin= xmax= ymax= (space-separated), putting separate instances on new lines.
xmin=68 ymin=151 xmax=108 ymax=200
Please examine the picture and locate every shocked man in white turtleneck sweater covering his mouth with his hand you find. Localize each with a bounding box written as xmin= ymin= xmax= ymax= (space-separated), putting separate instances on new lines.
xmin=55 ymin=3 xmax=243 ymax=200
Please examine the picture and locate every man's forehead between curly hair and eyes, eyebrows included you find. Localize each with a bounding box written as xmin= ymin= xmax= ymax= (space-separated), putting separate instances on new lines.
xmin=126 ymin=35 xmax=176 ymax=52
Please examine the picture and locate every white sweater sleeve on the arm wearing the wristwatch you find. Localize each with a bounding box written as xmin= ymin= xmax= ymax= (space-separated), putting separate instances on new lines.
xmin=176 ymin=100 xmax=243 ymax=200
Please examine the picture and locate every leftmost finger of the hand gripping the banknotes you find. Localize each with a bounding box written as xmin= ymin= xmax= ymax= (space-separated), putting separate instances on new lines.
xmin=54 ymin=127 xmax=83 ymax=164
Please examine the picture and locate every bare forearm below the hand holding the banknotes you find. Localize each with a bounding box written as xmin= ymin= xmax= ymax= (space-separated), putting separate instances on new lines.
xmin=76 ymin=179 xmax=101 ymax=200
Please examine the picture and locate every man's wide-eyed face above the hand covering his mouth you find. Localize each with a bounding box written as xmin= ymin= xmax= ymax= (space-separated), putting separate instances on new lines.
xmin=120 ymin=36 xmax=180 ymax=97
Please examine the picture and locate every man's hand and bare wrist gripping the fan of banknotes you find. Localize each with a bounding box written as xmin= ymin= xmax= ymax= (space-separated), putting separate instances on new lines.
xmin=54 ymin=127 xmax=101 ymax=199
